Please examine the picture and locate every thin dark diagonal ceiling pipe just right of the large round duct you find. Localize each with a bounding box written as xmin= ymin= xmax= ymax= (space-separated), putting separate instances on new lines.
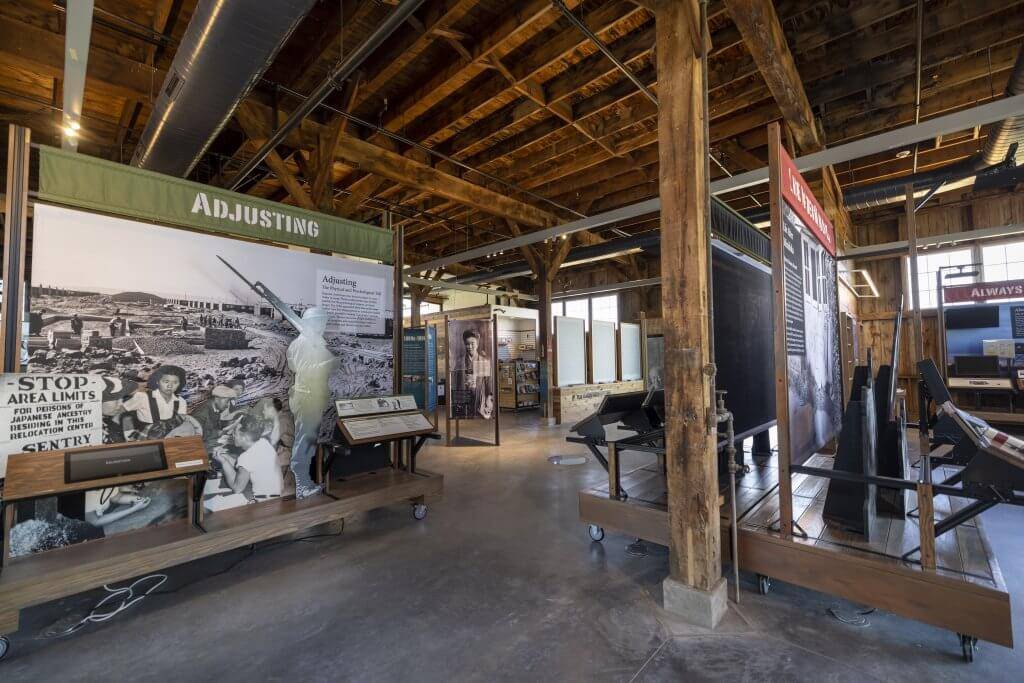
xmin=229 ymin=0 xmax=423 ymax=189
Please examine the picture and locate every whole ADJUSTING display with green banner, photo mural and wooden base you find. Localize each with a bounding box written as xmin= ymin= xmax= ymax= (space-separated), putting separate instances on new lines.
xmin=0 ymin=133 xmax=443 ymax=655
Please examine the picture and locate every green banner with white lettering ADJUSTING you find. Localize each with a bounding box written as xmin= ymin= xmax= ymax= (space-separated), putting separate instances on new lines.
xmin=39 ymin=145 xmax=392 ymax=262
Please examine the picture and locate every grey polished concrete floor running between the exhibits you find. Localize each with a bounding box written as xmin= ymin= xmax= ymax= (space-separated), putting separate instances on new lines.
xmin=0 ymin=414 xmax=1024 ymax=683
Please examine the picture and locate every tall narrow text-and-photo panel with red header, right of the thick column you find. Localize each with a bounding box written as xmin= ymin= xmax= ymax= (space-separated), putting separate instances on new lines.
xmin=772 ymin=148 xmax=843 ymax=465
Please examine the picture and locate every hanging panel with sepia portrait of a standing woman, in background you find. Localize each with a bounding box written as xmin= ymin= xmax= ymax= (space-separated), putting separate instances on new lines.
xmin=446 ymin=318 xmax=498 ymax=420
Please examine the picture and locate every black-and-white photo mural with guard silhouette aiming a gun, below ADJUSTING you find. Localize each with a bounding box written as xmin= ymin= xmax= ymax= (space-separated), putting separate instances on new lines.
xmin=15 ymin=203 xmax=393 ymax=540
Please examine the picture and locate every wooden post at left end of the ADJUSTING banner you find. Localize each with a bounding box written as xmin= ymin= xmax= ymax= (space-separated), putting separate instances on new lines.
xmin=0 ymin=124 xmax=32 ymax=373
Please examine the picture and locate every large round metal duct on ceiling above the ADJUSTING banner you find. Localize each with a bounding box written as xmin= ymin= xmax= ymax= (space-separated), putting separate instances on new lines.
xmin=131 ymin=0 xmax=315 ymax=176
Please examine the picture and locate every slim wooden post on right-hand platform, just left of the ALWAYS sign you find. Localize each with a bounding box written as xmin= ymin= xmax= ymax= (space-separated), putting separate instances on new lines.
xmin=904 ymin=184 xmax=942 ymax=571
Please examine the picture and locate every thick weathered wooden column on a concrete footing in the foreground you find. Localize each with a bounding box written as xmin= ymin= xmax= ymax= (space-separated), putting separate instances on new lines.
xmin=655 ymin=0 xmax=726 ymax=627
